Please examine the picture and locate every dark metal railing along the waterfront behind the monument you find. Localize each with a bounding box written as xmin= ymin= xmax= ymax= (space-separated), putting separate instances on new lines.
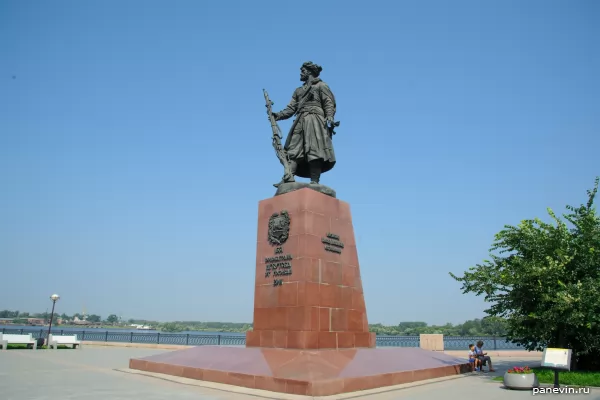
xmin=0 ymin=328 xmax=521 ymax=350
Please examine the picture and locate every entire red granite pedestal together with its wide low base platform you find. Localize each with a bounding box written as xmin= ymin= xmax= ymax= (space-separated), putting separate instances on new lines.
xmin=129 ymin=189 xmax=468 ymax=396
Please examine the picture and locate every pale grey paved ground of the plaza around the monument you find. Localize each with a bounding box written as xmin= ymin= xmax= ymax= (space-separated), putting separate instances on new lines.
xmin=0 ymin=346 xmax=600 ymax=400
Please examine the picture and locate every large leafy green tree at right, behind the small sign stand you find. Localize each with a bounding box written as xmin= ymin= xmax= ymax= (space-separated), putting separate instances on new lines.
xmin=450 ymin=178 xmax=600 ymax=369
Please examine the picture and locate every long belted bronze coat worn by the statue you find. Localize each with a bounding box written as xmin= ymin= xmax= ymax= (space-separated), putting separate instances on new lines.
xmin=278 ymin=78 xmax=336 ymax=178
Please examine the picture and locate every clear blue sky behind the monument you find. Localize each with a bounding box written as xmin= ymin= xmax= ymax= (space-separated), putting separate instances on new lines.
xmin=0 ymin=0 xmax=600 ymax=324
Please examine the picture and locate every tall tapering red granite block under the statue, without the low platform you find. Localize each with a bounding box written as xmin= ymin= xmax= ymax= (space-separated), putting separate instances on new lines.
xmin=246 ymin=189 xmax=375 ymax=349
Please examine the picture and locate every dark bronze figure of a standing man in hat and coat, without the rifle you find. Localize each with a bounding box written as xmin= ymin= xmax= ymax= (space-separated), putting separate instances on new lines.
xmin=273 ymin=61 xmax=336 ymax=187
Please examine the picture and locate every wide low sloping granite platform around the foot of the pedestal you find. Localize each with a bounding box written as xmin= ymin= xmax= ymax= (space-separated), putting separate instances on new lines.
xmin=129 ymin=346 xmax=469 ymax=396
